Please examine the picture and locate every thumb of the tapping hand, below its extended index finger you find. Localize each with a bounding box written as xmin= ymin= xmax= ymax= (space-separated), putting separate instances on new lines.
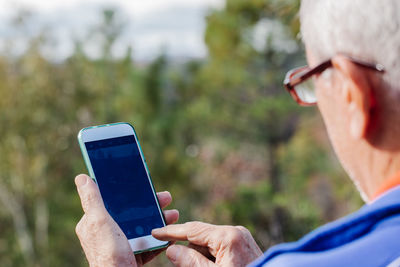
xmin=166 ymin=245 xmax=217 ymax=267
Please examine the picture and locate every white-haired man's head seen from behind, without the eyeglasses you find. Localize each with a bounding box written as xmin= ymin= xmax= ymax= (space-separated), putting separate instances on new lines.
xmin=300 ymin=0 xmax=400 ymax=199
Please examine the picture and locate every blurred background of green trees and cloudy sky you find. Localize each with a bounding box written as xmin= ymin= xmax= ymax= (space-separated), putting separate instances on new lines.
xmin=0 ymin=0 xmax=362 ymax=267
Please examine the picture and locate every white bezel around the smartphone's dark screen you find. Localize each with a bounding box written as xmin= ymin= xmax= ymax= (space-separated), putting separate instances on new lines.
xmin=78 ymin=123 xmax=168 ymax=254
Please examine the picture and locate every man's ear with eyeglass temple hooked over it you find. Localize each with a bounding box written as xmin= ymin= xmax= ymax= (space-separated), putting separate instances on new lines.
xmin=332 ymin=55 xmax=373 ymax=139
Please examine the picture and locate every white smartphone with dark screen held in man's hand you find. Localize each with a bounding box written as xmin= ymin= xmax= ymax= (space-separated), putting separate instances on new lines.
xmin=78 ymin=122 xmax=168 ymax=254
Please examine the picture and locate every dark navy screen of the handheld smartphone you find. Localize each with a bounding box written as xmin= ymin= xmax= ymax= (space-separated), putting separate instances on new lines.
xmin=85 ymin=135 xmax=164 ymax=239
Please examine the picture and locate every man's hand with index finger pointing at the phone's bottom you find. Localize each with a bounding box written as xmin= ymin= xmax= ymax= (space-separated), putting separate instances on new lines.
xmin=152 ymin=222 xmax=262 ymax=267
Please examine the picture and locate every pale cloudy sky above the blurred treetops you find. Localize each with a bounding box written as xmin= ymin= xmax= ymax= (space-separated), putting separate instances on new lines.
xmin=0 ymin=0 xmax=224 ymax=61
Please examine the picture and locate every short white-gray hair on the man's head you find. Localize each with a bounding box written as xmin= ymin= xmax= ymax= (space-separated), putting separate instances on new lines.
xmin=300 ymin=0 xmax=400 ymax=90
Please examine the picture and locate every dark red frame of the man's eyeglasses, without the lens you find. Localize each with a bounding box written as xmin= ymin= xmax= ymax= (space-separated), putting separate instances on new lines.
xmin=283 ymin=56 xmax=385 ymax=106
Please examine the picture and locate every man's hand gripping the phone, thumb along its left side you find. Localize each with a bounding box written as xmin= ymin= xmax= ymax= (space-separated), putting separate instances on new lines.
xmin=75 ymin=174 xmax=179 ymax=267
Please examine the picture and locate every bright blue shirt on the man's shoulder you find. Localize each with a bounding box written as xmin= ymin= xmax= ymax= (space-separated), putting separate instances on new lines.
xmin=249 ymin=186 xmax=400 ymax=267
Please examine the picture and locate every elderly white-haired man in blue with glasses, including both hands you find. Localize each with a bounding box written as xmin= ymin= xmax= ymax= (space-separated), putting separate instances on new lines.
xmin=76 ymin=0 xmax=400 ymax=266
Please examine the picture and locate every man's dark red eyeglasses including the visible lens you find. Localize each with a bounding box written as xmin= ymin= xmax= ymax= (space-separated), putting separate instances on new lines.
xmin=283 ymin=56 xmax=385 ymax=106
